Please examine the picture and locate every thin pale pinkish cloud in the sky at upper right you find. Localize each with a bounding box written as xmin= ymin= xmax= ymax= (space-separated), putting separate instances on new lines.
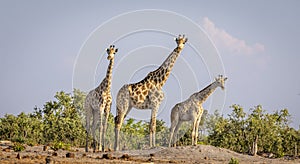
xmin=202 ymin=17 xmax=265 ymax=55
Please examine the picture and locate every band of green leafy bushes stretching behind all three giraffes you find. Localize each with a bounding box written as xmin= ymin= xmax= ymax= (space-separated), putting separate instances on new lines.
xmin=0 ymin=89 xmax=300 ymax=158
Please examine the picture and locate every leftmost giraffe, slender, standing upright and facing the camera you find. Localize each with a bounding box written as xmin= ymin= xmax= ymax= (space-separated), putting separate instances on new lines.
xmin=84 ymin=45 xmax=118 ymax=152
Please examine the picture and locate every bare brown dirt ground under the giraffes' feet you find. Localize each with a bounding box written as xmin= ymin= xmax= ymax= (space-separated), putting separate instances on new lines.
xmin=0 ymin=142 xmax=300 ymax=164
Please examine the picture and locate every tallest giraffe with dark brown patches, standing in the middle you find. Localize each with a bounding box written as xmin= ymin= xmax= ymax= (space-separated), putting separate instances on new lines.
xmin=114 ymin=35 xmax=188 ymax=151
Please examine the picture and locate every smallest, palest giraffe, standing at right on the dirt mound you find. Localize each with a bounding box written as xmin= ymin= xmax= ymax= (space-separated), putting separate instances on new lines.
xmin=169 ymin=75 xmax=227 ymax=147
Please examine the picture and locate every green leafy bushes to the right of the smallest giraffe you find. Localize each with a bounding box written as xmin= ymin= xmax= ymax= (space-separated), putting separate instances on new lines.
xmin=207 ymin=105 xmax=300 ymax=157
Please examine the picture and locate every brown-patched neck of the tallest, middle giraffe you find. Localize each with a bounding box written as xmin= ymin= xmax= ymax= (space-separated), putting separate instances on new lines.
xmin=149 ymin=47 xmax=182 ymax=88
